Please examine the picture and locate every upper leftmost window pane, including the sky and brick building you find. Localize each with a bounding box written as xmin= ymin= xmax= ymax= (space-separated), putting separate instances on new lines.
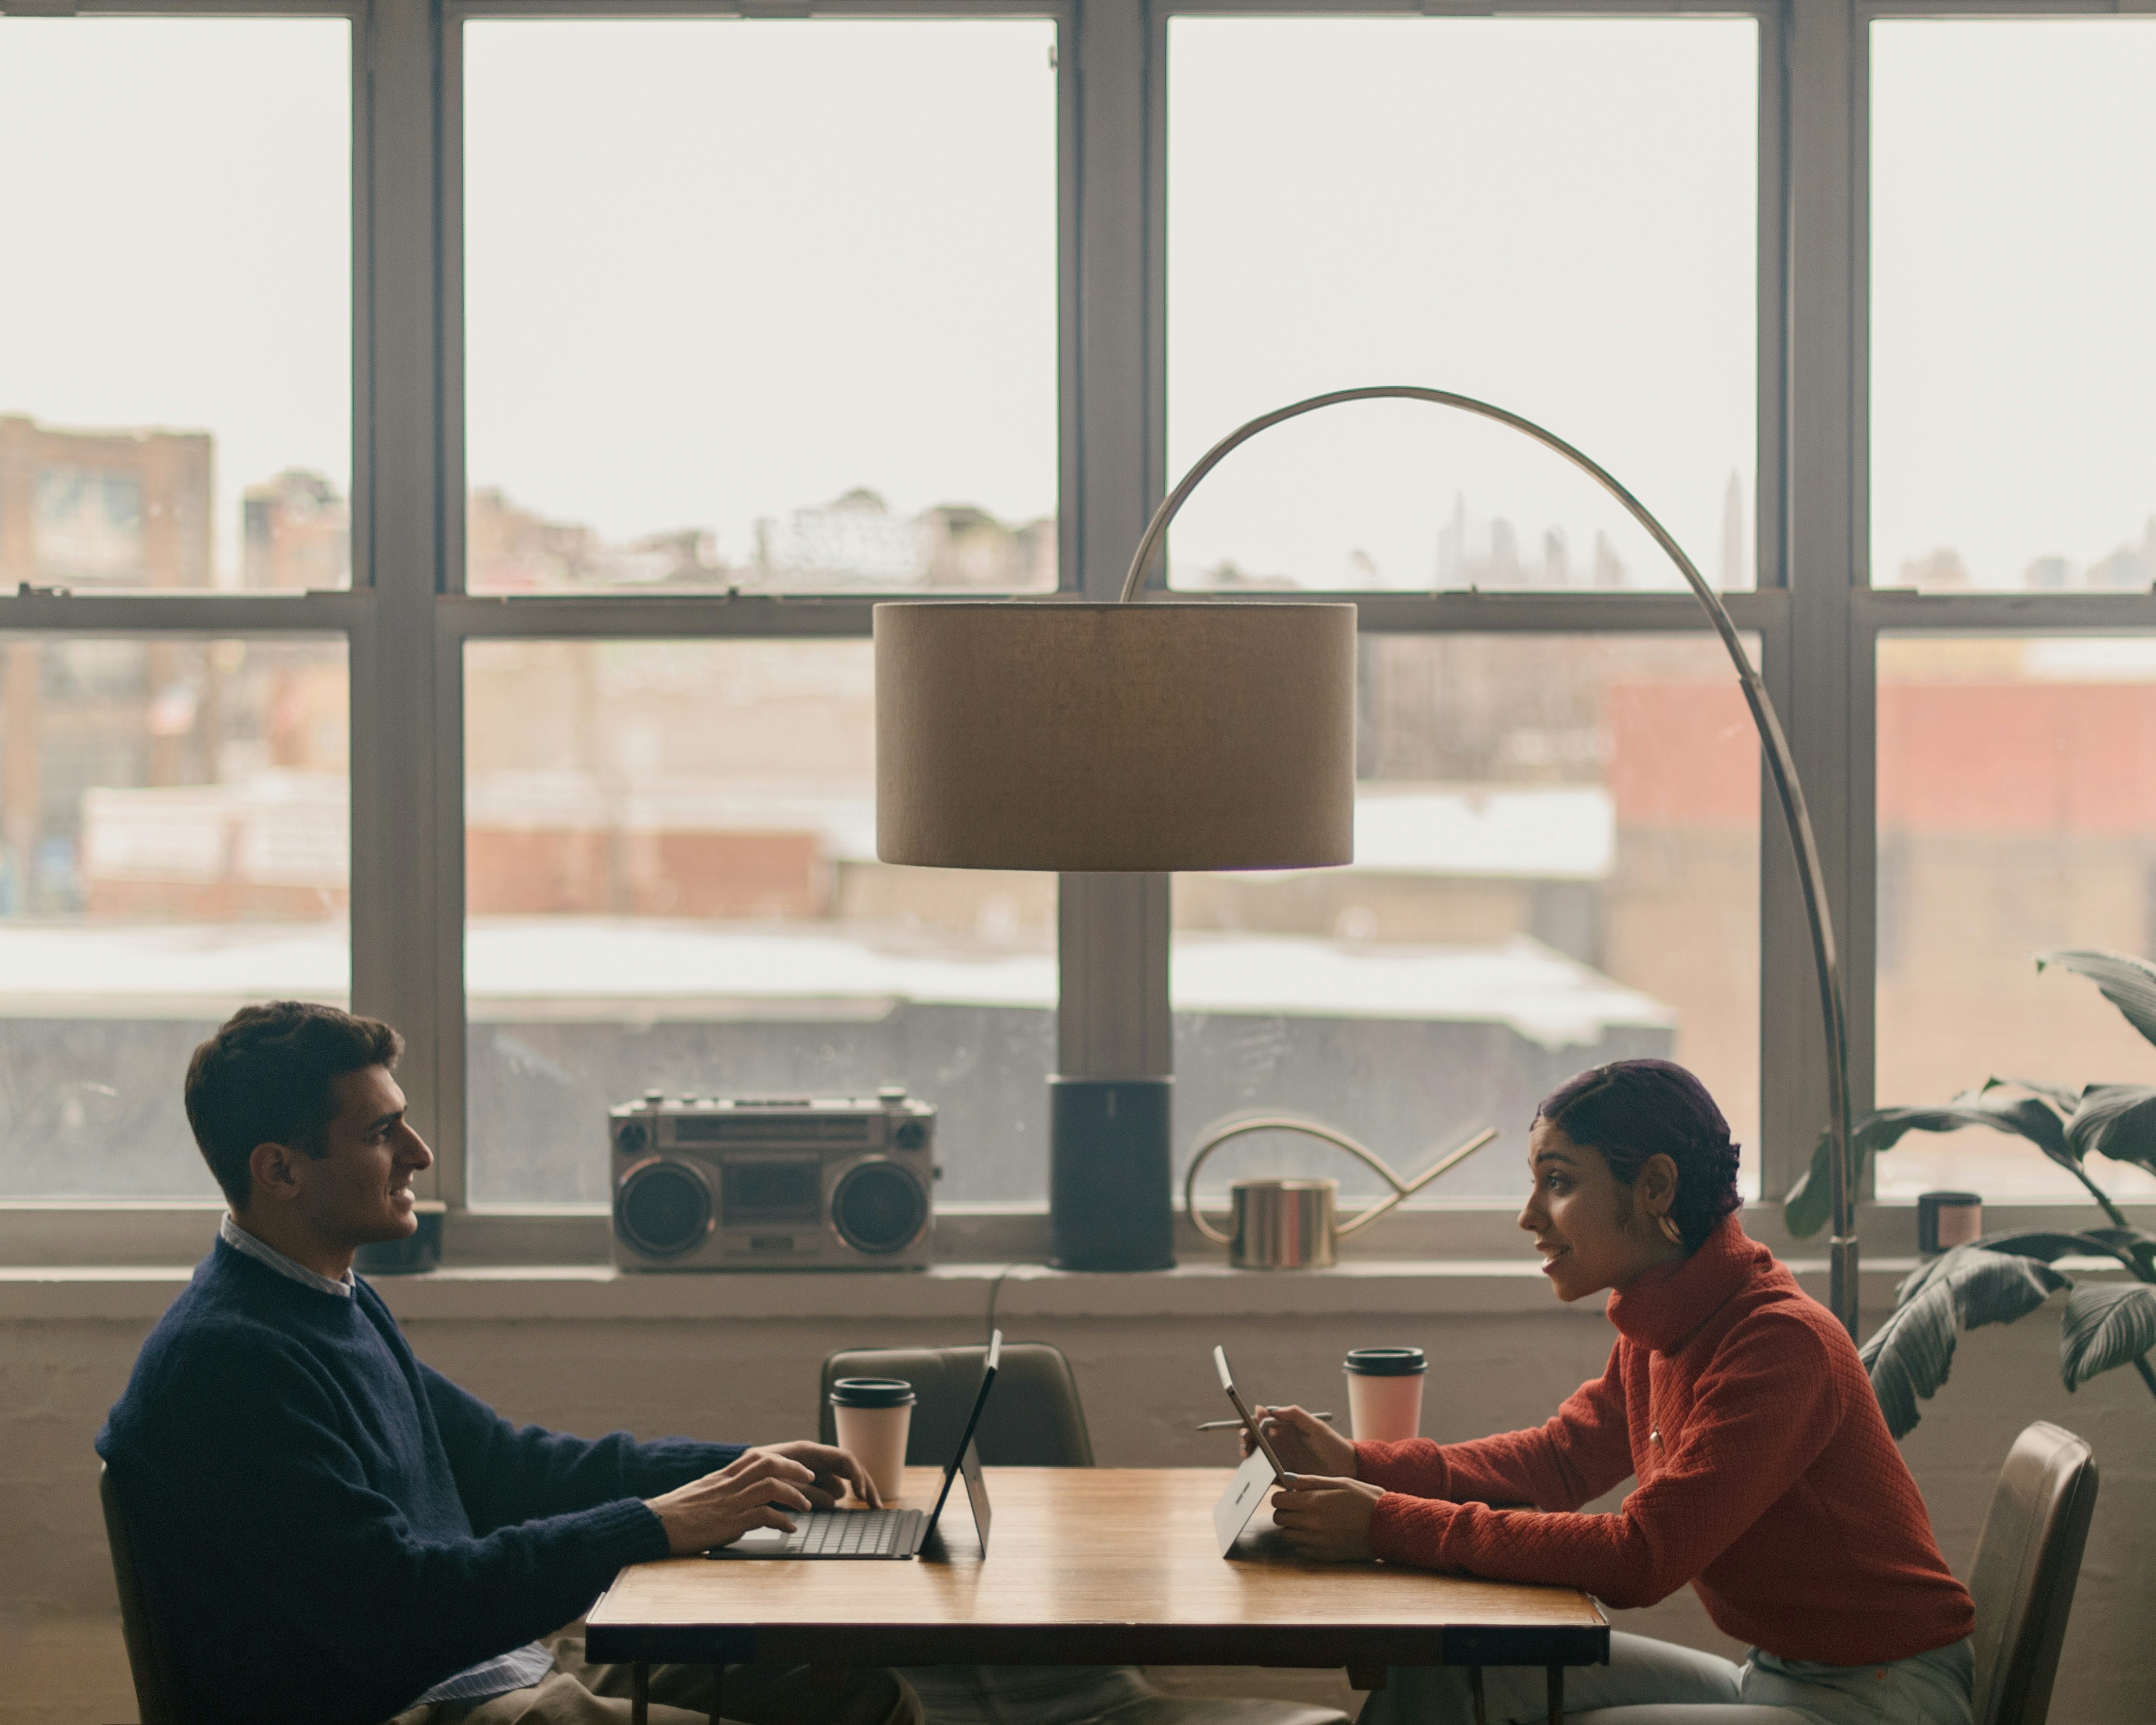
xmin=0 ymin=17 xmax=352 ymax=591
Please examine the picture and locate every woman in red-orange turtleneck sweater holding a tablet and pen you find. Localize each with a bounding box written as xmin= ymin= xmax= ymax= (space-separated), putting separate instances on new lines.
xmin=1259 ymin=1061 xmax=1975 ymax=1725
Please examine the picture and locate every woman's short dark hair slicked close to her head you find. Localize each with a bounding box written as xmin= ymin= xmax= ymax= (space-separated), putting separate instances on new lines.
xmin=1535 ymin=1061 xmax=1744 ymax=1253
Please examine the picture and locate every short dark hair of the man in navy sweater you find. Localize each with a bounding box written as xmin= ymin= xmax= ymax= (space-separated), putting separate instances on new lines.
xmin=187 ymin=1001 xmax=403 ymax=1210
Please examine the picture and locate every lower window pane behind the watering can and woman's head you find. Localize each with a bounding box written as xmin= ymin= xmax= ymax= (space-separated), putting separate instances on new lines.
xmin=1173 ymin=636 xmax=1759 ymax=1197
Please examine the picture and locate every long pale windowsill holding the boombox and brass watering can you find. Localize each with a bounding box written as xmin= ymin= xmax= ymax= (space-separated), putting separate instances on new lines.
xmin=0 ymin=1255 xmax=2106 ymax=1326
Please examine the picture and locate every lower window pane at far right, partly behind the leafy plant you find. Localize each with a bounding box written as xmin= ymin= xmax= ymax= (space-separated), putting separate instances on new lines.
xmin=1878 ymin=636 xmax=2156 ymax=1198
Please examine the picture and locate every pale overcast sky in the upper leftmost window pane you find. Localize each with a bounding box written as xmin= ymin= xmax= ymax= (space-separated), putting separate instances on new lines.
xmin=0 ymin=17 xmax=352 ymax=586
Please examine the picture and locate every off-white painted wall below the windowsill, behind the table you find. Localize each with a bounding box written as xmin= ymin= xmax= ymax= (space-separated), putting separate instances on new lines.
xmin=0 ymin=1283 xmax=2156 ymax=1725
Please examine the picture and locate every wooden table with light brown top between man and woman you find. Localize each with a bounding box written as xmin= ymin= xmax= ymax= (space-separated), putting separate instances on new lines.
xmin=587 ymin=1468 xmax=1610 ymax=1718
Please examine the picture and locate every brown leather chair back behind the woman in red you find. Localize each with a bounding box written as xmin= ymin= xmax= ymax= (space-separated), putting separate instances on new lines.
xmin=1969 ymin=1419 xmax=2096 ymax=1725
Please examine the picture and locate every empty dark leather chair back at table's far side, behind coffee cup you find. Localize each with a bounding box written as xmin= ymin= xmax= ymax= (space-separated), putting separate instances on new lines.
xmin=817 ymin=1341 xmax=1093 ymax=1468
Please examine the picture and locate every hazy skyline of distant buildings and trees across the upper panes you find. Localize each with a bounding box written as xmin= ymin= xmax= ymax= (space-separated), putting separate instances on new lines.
xmin=0 ymin=414 xmax=2156 ymax=591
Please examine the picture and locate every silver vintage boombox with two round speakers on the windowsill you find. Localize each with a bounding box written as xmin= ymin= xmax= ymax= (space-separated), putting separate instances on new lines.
xmin=606 ymin=1089 xmax=936 ymax=1270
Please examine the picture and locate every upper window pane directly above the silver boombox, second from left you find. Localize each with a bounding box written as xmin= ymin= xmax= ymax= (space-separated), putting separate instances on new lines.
xmin=464 ymin=20 xmax=1056 ymax=593
